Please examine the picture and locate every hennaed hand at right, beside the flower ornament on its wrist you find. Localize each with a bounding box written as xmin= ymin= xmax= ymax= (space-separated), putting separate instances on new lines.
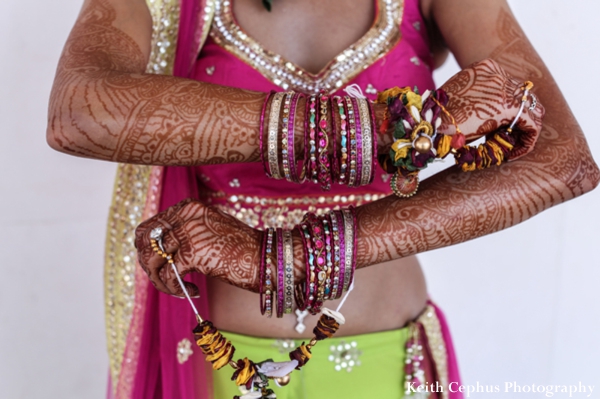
xmin=439 ymin=59 xmax=545 ymax=159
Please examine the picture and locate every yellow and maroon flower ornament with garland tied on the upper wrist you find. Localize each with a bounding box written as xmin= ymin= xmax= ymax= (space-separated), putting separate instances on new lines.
xmin=376 ymin=81 xmax=537 ymax=198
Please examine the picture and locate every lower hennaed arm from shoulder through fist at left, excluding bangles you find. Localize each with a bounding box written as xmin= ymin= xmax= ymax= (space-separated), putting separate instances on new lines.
xmin=136 ymin=0 xmax=600 ymax=294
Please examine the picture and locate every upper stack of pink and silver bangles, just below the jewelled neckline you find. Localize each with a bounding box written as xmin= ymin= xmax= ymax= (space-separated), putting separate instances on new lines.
xmin=260 ymin=92 xmax=377 ymax=191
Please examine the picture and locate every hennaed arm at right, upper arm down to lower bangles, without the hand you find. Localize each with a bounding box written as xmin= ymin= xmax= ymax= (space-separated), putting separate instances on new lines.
xmin=357 ymin=0 xmax=600 ymax=267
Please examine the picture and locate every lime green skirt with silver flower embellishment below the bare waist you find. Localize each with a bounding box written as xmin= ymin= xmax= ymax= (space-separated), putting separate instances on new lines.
xmin=213 ymin=328 xmax=409 ymax=399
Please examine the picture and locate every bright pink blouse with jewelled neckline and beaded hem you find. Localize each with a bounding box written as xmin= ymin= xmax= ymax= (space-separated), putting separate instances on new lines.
xmin=191 ymin=0 xmax=434 ymax=228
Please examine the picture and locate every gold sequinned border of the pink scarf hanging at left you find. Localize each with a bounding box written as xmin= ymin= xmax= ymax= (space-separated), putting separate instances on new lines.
xmin=104 ymin=0 xmax=179 ymax=397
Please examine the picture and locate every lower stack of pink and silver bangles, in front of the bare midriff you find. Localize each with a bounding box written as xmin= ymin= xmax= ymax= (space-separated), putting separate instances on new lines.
xmin=259 ymin=207 xmax=356 ymax=317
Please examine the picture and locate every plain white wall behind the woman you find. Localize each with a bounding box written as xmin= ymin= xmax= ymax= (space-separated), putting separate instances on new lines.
xmin=0 ymin=0 xmax=600 ymax=399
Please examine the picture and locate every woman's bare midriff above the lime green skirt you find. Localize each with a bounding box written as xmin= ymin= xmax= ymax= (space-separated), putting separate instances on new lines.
xmin=208 ymin=256 xmax=427 ymax=339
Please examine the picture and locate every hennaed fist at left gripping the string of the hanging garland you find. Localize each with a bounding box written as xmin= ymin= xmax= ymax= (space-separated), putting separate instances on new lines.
xmin=135 ymin=200 xmax=262 ymax=296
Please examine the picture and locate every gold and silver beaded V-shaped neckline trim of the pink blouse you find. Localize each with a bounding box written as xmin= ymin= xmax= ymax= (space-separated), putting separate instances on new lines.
xmin=210 ymin=0 xmax=404 ymax=94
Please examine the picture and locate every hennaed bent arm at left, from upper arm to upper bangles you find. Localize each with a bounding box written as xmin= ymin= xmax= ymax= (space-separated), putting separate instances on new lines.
xmin=47 ymin=0 xmax=265 ymax=165
